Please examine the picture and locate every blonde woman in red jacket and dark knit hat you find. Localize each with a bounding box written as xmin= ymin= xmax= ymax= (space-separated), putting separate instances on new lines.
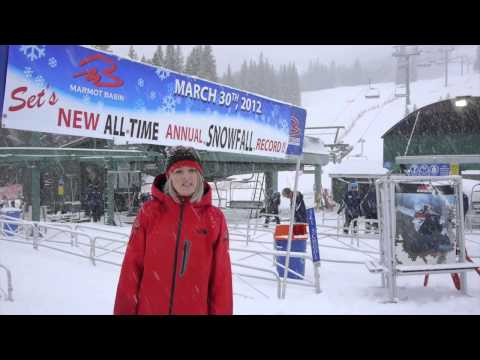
xmin=114 ymin=146 xmax=233 ymax=315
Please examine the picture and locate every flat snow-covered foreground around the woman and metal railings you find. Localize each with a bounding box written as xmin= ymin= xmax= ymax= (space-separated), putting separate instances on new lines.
xmin=0 ymin=213 xmax=480 ymax=314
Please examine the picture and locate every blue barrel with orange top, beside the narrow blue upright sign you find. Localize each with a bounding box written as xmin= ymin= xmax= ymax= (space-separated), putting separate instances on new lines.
xmin=275 ymin=224 xmax=307 ymax=280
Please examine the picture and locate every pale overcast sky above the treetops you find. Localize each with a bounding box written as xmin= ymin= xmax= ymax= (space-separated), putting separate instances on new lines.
xmin=112 ymin=45 xmax=393 ymax=75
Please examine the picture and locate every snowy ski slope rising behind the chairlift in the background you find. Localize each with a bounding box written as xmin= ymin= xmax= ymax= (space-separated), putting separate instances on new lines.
xmin=279 ymin=71 xmax=480 ymax=198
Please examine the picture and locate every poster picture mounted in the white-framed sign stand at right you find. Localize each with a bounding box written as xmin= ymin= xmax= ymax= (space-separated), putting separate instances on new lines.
xmin=395 ymin=182 xmax=459 ymax=265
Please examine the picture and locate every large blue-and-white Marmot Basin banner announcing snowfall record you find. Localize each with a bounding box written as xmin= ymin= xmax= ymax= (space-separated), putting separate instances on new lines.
xmin=0 ymin=45 xmax=306 ymax=157
